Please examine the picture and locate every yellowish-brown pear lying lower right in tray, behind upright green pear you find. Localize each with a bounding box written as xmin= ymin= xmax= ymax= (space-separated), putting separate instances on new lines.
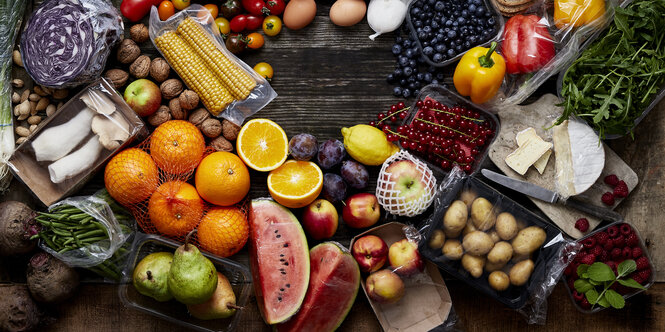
xmin=187 ymin=272 xmax=241 ymax=319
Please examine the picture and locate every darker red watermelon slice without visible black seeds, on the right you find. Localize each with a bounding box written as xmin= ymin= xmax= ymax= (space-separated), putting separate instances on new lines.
xmin=275 ymin=242 xmax=360 ymax=332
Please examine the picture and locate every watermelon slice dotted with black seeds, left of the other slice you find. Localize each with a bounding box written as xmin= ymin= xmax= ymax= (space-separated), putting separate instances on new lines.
xmin=249 ymin=199 xmax=309 ymax=325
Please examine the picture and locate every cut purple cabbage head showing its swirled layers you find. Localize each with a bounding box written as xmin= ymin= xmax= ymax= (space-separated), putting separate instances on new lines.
xmin=21 ymin=0 xmax=124 ymax=88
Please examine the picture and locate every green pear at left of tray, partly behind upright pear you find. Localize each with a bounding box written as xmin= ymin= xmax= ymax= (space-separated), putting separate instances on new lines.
xmin=132 ymin=252 xmax=173 ymax=302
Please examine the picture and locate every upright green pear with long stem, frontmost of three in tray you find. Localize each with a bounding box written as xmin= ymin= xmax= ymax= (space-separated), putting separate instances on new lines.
xmin=168 ymin=230 xmax=217 ymax=304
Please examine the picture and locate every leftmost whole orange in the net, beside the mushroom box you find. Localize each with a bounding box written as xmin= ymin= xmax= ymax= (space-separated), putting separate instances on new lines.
xmin=104 ymin=148 xmax=159 ymax=205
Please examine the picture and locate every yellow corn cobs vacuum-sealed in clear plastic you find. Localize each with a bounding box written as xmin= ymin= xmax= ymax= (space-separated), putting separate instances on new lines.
xmin=150 ymin=5 xmax=277 ymax=125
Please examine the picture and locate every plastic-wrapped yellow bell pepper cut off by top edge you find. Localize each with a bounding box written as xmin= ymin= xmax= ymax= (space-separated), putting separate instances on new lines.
xmin=554 ymin=0 xmax=605 ymax=29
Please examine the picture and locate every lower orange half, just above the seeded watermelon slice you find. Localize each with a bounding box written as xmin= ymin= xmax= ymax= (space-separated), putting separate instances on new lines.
xmin=268 ymin=160 xmax=323 ymax=208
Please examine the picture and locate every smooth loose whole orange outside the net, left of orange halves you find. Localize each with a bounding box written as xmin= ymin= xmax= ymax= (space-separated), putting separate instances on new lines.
xmin=194 ymin=152 xmax=249 ymax=206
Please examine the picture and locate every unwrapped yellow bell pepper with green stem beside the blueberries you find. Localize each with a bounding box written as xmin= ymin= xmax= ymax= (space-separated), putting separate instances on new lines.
xmin=453 ymin=42 xmax=506 ymax=104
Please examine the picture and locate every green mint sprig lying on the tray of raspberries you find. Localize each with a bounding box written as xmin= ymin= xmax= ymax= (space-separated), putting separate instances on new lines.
xmin=574 ymin=259 xmax=645 ymax=309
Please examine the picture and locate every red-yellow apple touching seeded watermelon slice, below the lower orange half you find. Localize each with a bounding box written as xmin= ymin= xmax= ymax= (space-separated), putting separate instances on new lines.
xmin=302 ymin=199 xmax=339 ymax=240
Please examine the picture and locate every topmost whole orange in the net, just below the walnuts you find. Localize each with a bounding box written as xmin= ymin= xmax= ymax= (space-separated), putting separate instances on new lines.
xmin=150 ymin=120 xmax=205 ymax=174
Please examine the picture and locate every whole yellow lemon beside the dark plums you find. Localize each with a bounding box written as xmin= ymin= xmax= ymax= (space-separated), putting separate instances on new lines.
xmin=342 ymin=125 xmax=399 ymax=166
